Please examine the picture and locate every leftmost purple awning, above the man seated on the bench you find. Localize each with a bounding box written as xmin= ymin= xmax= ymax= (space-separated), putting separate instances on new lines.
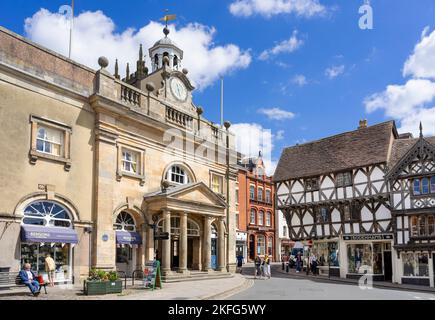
xmin=21 ymin=225 xmax=79 ymax=243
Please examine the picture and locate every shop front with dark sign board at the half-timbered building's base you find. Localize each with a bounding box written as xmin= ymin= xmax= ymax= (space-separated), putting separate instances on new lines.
xmin=343 ymin=234 xmax=393 ymax=281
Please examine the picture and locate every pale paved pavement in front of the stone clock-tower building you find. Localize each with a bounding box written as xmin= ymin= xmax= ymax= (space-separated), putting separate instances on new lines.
xmin=0 ymin=274 xmax=253 ymax=300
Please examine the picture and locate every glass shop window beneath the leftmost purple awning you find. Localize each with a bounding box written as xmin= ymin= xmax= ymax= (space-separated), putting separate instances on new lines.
xmin=21 ymin=243 xmax=71 ymax=282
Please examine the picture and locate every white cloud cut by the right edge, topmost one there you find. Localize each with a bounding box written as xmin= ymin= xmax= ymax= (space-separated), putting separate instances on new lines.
xmin=403 ymin=27 xmax=435 ymax=79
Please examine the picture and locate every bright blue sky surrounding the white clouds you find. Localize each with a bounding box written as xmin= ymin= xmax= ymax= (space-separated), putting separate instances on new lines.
xmin=0 ymin=0 xmax=435 ymax=174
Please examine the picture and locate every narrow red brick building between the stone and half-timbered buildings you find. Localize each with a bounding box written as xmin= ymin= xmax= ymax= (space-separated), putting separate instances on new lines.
xmin=236 ymin=153 xmax=275 ymax=261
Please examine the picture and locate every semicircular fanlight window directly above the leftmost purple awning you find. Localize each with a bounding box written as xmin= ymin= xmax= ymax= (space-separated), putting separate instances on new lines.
xmin=22 ymin=201 xmax=72 ymax=228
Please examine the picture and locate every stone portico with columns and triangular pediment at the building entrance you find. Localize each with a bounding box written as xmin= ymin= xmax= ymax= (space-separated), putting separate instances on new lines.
xmin=144 ymin=182 xmax=227 ymax=275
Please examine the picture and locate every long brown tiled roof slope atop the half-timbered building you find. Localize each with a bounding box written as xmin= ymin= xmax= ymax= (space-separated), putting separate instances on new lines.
xmin=273 ymin=121 xmax=398 ymax=182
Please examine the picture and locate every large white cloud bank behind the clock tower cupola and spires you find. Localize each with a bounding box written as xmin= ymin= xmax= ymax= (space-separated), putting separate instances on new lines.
xmin=25 ymin=9 xmax=251 ymax=89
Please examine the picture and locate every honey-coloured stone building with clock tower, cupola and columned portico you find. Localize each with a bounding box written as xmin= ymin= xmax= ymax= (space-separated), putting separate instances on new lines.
xmin=0 ymin=28 xmax=237 ymax=282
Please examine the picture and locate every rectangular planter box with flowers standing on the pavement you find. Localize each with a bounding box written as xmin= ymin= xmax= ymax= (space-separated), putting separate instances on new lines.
xmin=85 ymin=269 xmax=122 ymax=295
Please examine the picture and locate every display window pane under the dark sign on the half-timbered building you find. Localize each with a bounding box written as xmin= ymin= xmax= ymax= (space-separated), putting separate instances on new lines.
xmin=347 ymin=243 xmax=383 ymax=274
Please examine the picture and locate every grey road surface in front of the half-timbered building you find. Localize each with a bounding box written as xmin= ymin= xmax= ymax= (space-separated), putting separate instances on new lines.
xmin=228 ymin=265 xmax=435 ymax=300
